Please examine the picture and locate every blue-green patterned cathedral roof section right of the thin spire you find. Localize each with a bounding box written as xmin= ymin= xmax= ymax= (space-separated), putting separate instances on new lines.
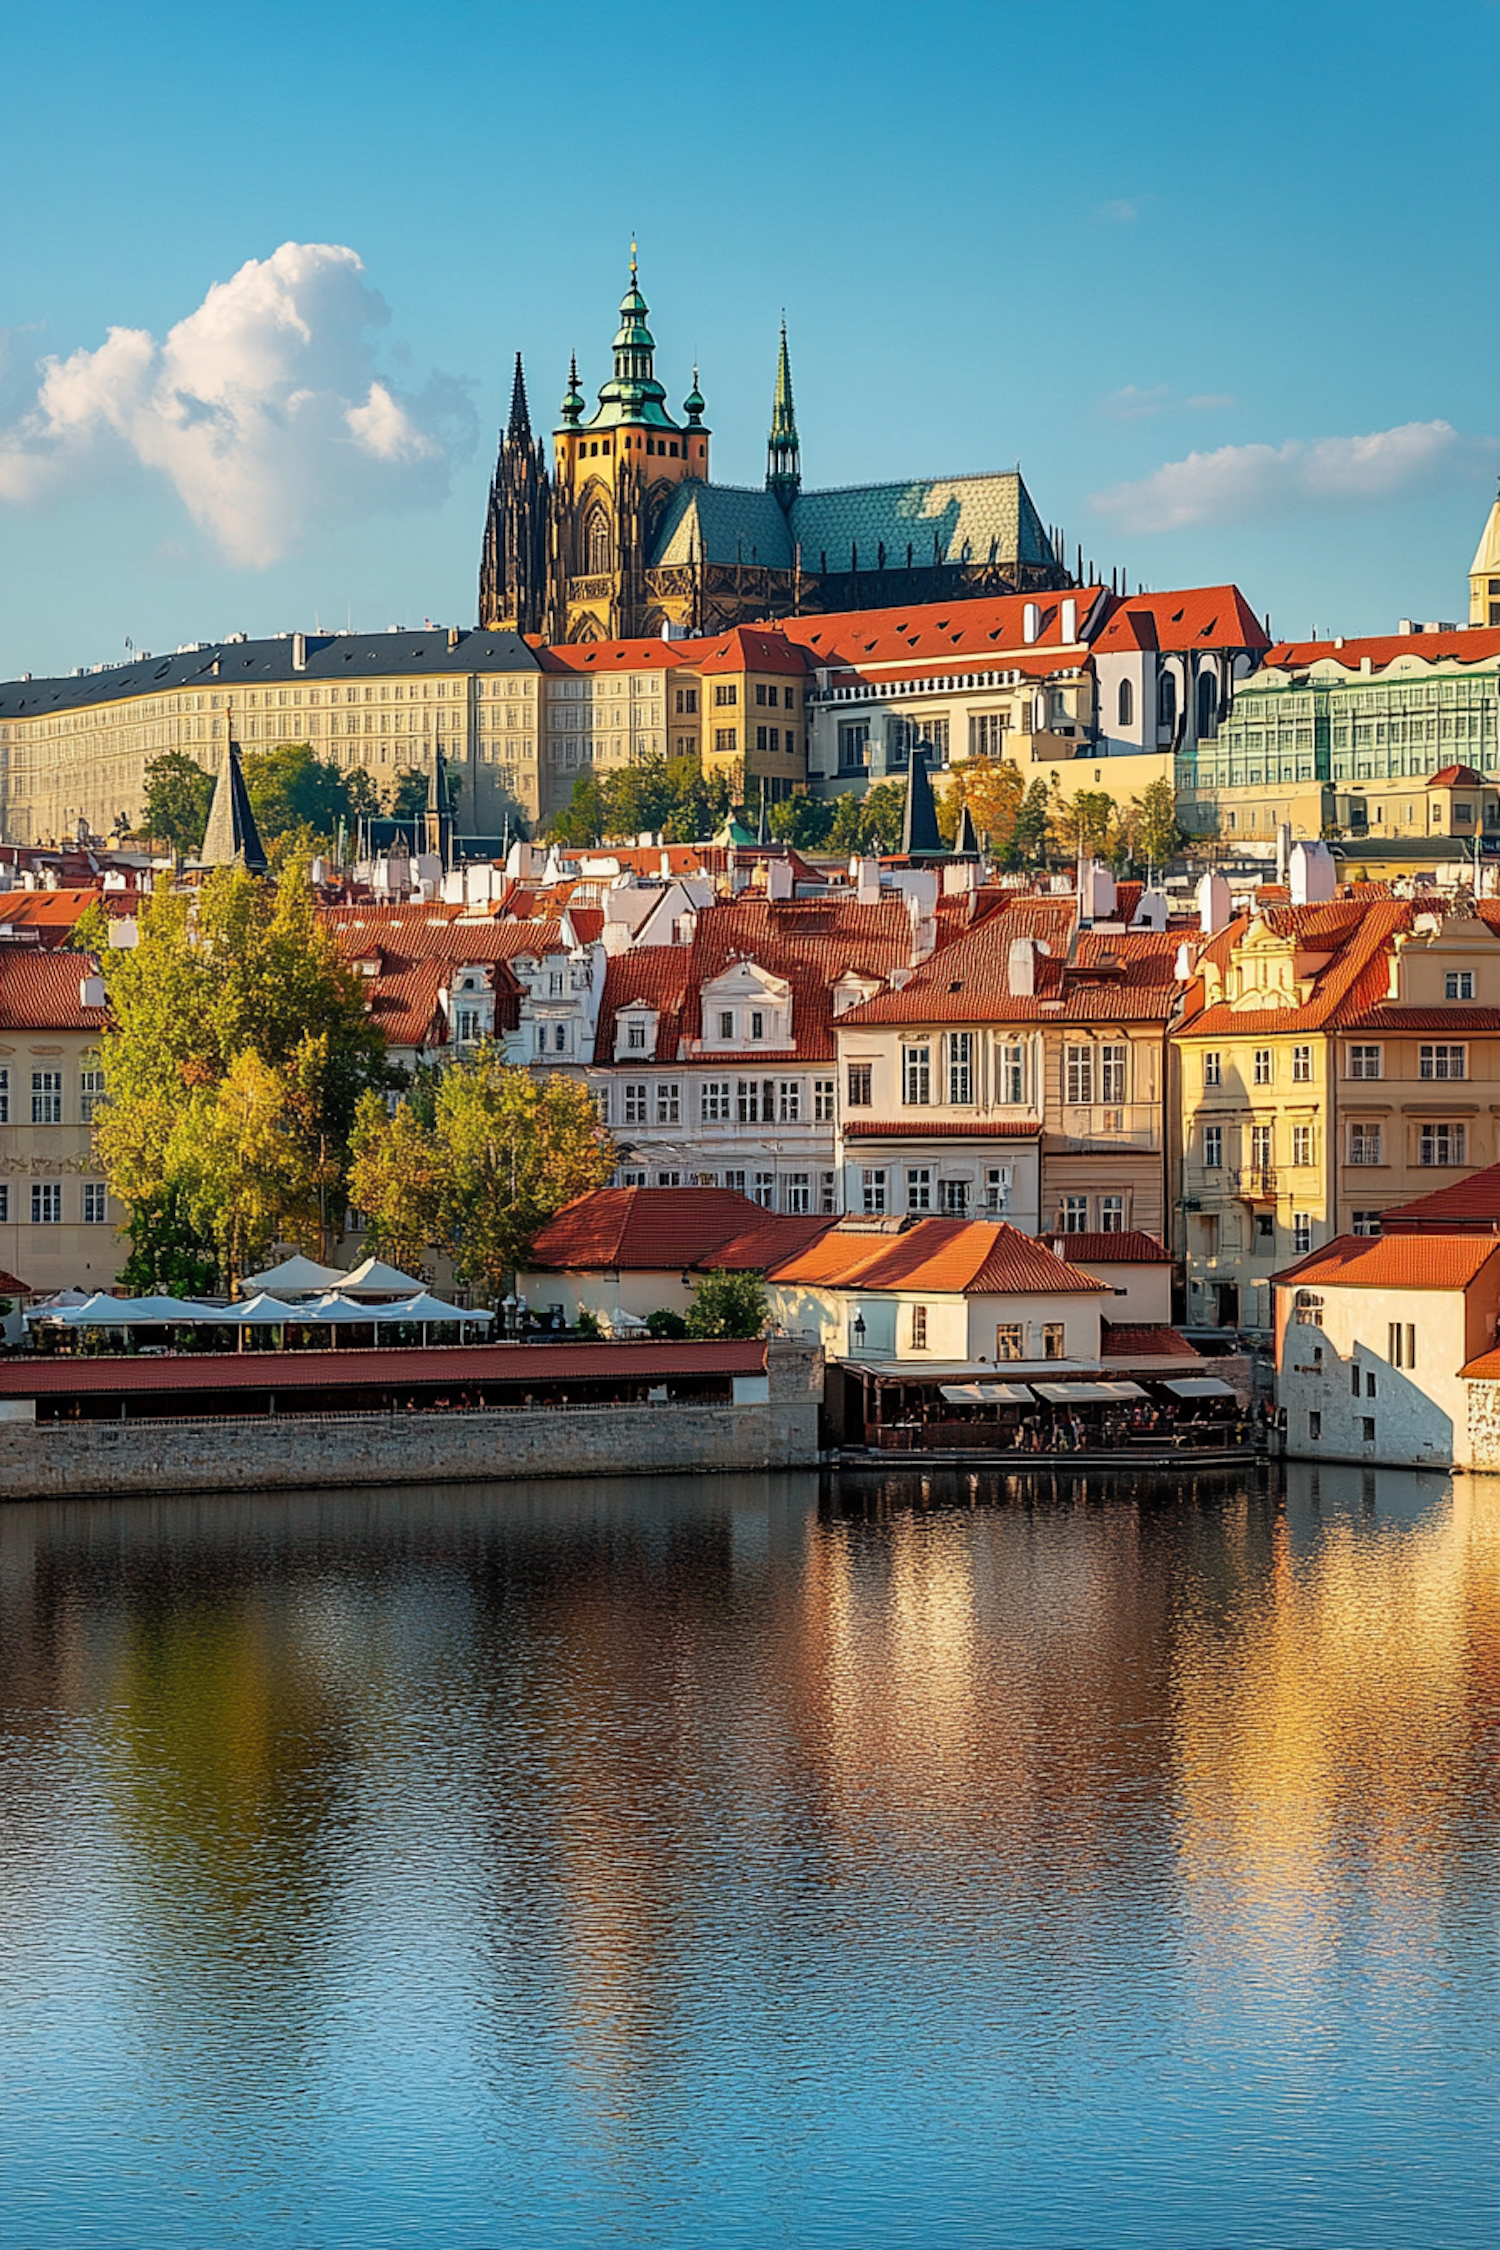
xmin=792 ymin=470 xmax=1055 ymax=572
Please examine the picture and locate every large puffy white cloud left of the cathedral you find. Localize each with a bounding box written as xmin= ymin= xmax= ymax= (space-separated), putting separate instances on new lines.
xmin=0 ymin=243 xmax=475 ymax=567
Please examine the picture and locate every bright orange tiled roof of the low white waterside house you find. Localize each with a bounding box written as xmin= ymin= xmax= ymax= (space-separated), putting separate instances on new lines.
xmin=771 ymin=1220 xmax=1109 ymax=1296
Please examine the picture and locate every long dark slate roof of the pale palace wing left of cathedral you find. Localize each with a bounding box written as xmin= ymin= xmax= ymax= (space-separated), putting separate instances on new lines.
xmin=0 ymin=625 xmax=539 ymax=718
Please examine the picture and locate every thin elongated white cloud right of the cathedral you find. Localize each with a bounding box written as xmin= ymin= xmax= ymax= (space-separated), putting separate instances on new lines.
xmin=1091 ymin=421 xmax=1493 ymax=531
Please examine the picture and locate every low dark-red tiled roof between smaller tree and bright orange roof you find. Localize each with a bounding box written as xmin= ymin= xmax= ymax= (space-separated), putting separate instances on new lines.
xmin=531 ymin=1188 xmax=834 ymax=1274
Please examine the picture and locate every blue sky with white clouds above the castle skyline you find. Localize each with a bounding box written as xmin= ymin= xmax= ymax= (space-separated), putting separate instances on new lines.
xmin=0 ymin=0 xmax=1500 ymax=675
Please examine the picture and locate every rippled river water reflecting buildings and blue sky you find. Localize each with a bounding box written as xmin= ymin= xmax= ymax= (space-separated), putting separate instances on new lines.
xmin=0 ymin=1469 xmax=1500 ymax=2250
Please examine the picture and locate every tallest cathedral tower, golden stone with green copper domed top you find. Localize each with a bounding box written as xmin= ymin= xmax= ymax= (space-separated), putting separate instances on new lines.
xmin=546 ymin=243 xmax=708 ymax=641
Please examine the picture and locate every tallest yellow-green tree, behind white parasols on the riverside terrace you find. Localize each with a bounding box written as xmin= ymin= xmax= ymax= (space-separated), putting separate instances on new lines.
xmin=94 ymin=864 xmax=389 ymax=1274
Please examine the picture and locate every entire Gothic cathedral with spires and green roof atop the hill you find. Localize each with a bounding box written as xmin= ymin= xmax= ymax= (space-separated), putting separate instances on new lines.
xmin=479 ymin=248 xmax=1075 ymax=641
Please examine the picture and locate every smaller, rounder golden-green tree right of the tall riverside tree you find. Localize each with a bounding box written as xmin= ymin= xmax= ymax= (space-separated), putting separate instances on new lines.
xmin=349 ymin=1046 xmax=616 ymax=1296
